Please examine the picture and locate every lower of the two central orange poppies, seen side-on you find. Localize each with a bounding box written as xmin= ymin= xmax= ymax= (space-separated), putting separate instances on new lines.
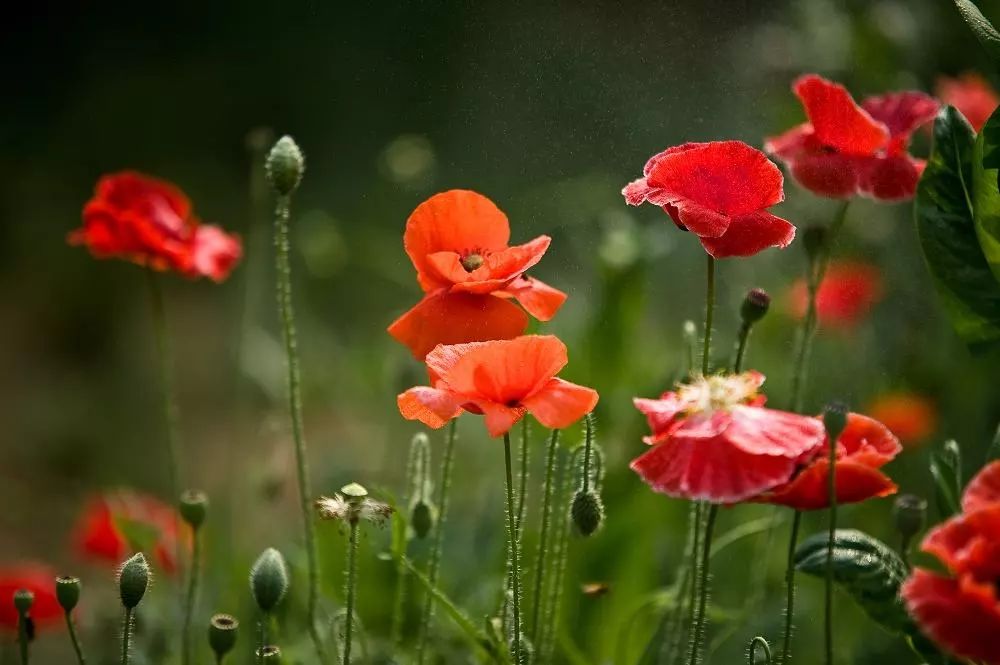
xmin=397 ymin=335 xmax=597 ymax=437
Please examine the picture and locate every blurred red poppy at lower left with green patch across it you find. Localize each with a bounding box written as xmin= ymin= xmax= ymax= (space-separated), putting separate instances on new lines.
xmin=75 ymin=489 xmax=190 ymax=574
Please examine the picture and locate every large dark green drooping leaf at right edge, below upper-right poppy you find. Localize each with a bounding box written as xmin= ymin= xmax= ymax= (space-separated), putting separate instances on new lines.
xmin=913 ymin=106 xmax=1000 ymax=349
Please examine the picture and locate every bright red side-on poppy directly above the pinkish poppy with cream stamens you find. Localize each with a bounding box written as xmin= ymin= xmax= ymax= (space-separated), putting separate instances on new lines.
xmin=622 ymin=141 xmax=795 ymax=259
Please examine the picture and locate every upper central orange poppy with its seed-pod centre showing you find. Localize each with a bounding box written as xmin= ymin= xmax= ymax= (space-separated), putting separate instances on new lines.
xmin=389 ymin=189 xmax=566 ymax=359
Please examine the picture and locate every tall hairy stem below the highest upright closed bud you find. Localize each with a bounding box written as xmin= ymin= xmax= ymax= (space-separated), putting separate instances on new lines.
xmin=274 ymin=196 xmax=327 ymax=663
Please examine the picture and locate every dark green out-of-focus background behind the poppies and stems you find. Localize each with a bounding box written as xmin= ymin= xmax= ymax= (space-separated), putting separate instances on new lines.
xmin=0 ymin=0 xmax=1000 ymax=665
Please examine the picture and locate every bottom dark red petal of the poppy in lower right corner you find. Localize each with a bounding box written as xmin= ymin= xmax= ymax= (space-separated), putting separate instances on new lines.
xmin=901 ymin=569 xmax=1000 ymax=663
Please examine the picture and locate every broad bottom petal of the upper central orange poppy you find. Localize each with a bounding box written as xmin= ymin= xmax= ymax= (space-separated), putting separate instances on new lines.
xmin=388 ymin=291 xmax=528 ymax=359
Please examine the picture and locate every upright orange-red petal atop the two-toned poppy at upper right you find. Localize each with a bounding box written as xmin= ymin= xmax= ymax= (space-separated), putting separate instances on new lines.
xmin=793 ymin=74 xmax=889 ymax=155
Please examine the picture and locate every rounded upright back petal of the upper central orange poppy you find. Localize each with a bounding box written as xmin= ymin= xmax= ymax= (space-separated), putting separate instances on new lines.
xmin=403 ymin=189 xmax=510 ymax=291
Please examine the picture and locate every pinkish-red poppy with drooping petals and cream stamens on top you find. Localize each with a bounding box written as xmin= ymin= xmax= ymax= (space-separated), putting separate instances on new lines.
xmin=631 ymin=372 xmax=824 ymax=503
